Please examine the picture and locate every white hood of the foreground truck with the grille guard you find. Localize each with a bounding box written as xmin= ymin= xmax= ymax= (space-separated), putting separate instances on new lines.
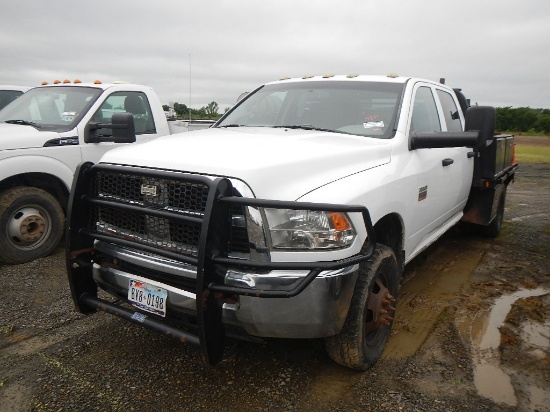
xmin=101 ymin=127 xmax=391 ymax=200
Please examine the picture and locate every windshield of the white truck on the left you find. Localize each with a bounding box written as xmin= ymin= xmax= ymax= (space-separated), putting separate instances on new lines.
xmin=0 ymin=86 xmax=102 ymax=132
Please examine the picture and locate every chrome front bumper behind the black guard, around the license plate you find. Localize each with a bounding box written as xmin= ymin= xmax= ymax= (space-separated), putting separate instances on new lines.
xmin=93 ymin=242 xmax=359 ymax=338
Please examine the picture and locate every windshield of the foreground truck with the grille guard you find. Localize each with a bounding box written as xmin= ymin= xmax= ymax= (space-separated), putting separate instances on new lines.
xmin=217 ymin=81 xmax=403 ymax=138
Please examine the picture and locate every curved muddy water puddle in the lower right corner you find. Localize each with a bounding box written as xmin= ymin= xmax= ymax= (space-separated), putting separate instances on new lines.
xmin=470 ymin=288 xmax=550 ymax=406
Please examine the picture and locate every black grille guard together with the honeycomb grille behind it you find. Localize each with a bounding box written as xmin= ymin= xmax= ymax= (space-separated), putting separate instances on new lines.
xmin=66 ymin=162 xmax=375 ymax=364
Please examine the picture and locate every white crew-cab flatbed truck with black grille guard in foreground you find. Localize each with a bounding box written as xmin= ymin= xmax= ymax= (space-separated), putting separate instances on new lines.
xmin=66 ymin=75 xmax=517 ymax=370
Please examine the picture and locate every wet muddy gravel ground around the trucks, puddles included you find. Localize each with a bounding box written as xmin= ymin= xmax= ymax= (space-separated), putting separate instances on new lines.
xmin=0 ymin=144 xmax=550 ymax=411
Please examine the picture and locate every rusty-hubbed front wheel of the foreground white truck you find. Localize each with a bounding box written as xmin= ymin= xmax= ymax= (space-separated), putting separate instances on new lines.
xmin=325 ymin=244 xmax=401 ymax=370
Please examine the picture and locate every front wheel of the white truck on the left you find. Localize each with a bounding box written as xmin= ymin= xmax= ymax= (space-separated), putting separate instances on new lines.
xmin=0 ymin=187 xmax=64 ymax=264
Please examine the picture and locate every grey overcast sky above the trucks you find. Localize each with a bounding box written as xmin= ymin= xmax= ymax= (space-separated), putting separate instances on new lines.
xmin=0 ymin=0 xmax=550 ymax=112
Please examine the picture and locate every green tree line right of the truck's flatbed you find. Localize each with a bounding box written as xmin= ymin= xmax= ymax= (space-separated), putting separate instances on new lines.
xmin=496 ymin=107 xmax=550 ymax=134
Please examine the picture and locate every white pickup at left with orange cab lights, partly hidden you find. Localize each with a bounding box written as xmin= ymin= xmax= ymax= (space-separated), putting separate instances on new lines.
xmin=0 ymin=81 xmax=192 ymax=263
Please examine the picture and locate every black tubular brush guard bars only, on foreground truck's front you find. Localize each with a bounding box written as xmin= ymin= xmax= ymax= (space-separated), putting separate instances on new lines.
xmin=66 ymin=162 xmax=376 ymax=364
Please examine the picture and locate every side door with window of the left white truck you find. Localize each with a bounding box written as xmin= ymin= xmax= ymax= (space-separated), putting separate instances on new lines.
xmin=79 ymin=91 xmax=159 ymax=163
